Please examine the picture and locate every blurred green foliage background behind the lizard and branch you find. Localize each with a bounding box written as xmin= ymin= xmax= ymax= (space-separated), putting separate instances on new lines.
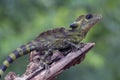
xmin=0 ymin=0 xmax=120 ymax=80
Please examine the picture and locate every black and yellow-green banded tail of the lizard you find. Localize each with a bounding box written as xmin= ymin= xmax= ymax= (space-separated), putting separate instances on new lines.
xmin=0 ymin=42 xmax=37 ymax=78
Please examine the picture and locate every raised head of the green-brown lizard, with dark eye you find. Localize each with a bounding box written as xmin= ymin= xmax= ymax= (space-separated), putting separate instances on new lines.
xmin=70 ymin=14 xmax=102 ymax=36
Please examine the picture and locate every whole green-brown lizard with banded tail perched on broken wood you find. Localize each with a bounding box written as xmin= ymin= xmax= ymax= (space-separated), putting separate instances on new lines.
xmin=0 ymin=14 xmax=102 ymax=77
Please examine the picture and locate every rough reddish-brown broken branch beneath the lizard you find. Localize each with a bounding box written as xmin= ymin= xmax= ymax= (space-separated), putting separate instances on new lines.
xmin=5 ymin=43 xmax=95 ymax=80
